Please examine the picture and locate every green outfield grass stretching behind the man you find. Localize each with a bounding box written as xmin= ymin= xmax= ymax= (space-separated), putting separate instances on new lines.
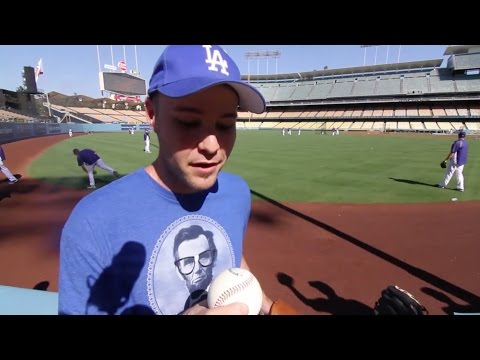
xmin=29 ymin=131 xmax=480 ymax=203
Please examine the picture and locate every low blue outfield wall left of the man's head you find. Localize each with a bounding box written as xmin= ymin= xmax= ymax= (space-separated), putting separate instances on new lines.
xmin=0 ymin=122 xmax=149 ymax=144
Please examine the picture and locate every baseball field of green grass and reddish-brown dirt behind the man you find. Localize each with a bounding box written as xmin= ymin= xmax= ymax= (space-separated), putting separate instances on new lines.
xmin=0 ymin=131 xmax=480 ymax=315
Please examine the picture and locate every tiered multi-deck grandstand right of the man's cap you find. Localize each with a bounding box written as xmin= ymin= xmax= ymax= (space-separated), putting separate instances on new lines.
xmin=237 ymin=45 xmax=480 ymax=133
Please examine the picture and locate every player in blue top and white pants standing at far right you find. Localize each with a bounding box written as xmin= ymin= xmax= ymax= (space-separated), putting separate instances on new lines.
xmin=437 ymin=130 xmax=468 ymax=192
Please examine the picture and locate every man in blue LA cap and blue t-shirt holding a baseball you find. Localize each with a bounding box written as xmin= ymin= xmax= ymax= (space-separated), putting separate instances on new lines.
xmin=59 ymin=45 xmax=273 ymax=314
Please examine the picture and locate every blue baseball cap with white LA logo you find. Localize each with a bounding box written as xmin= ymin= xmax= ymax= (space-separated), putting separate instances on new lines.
xmin=148 ymin=45 xmax=265 ymax=114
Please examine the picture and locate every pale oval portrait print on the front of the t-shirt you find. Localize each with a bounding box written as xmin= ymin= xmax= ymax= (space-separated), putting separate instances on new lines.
xmin=147 ymin=215 xmax=235 ymax=314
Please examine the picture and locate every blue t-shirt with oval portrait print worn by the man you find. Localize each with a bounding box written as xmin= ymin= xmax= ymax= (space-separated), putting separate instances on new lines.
xmin=59 ymin=168 xmax=251 ymax=314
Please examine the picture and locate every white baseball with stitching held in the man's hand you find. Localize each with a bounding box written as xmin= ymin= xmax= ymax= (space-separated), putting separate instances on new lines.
xmin=207 ymin=268 xmax=263 ymax=315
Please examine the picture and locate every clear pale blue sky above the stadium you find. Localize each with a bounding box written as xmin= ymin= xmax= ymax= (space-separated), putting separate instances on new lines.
xmin=0 ymin=45 xmax=447 ymax=98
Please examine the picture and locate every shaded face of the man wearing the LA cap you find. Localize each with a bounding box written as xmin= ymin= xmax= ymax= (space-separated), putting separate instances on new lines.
xmin=146 ymin=85 xmax=238 ymax=193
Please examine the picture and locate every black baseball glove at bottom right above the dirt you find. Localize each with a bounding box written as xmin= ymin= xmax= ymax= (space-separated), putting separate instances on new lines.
xmin=373 ymin=285 xmax=428 ymax=315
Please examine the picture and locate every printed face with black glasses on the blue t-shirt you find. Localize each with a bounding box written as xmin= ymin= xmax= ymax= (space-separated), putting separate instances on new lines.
xmin=175 ymin=235 xmax=215 ymax=293
